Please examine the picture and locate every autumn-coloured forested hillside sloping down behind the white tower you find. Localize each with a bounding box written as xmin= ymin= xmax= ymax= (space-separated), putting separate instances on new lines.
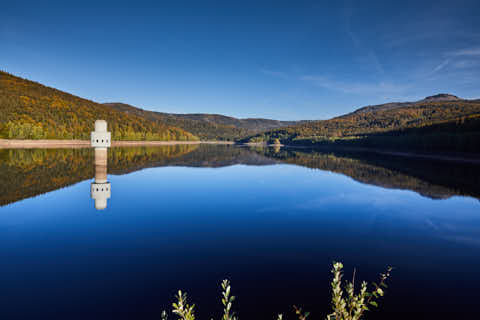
xmin=0 ymin=71 xmax=198 ymax=140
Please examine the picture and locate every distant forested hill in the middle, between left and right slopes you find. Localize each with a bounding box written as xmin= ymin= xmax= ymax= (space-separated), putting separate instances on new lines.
xmin=105 ymin=102 xmax=301 ymax=140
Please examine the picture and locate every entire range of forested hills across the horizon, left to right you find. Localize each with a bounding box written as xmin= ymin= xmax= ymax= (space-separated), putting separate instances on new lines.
xmin=0 ymin=71 xmax=480 ymax=153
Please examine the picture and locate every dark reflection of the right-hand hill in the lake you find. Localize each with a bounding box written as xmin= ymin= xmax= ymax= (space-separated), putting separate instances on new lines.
xmin=253 ymin=149 xmax=480 ymax=199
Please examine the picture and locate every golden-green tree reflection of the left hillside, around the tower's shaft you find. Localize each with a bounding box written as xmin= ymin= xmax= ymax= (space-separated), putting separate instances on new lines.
xmin=0 ymin=145 xmax=197 ymax=205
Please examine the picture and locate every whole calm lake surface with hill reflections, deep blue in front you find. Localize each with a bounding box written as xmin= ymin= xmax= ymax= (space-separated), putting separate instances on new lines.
xmin=0 ymin=145 xmax=480 ymax=319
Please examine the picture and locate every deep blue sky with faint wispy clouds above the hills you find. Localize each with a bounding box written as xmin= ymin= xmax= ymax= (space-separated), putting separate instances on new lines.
xmin=0 ymin=0 xmax=480 ymax=120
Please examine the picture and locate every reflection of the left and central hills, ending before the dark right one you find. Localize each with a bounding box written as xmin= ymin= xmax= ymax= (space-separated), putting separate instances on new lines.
xmin=0 ymin=145 xmax=275 ymax=205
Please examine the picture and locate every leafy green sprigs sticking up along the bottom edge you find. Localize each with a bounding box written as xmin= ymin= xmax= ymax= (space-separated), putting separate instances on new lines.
xmin=161 ymin=262 xmax=393 ymax=320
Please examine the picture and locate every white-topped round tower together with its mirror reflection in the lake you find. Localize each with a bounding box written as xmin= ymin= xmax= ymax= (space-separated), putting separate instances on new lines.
xmin=90 ymin=120 xmax=111 ymax=210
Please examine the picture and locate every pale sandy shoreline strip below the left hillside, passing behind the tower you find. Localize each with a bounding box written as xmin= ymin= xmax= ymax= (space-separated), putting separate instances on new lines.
xmin=0 ymin=139 xmax=234 ymax=149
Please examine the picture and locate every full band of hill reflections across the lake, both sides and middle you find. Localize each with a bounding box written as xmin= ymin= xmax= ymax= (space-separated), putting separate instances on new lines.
xmin=0 ymin=144 xmax=480 ymax=205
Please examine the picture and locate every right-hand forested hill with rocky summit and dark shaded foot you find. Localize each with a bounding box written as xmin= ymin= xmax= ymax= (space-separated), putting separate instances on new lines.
xmin=244 ymin=94 xmax=480 ymax=153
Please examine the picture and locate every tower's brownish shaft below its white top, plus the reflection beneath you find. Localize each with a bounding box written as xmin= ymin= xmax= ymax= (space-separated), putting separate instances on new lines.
xmin=90 ymin=148 xmax=111 ymax=210
